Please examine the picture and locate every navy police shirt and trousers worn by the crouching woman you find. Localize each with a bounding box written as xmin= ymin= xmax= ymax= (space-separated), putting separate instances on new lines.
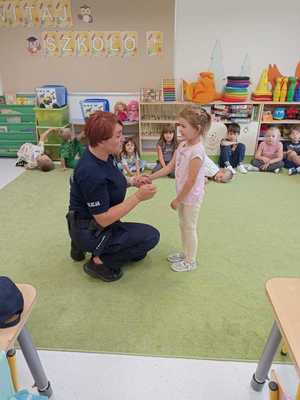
xmin=67 ymin=149 xmax=159 ymax=269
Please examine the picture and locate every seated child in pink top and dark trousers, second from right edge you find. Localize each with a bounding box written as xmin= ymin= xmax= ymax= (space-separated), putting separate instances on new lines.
xmin=248 ymin=126 xmax=283 ymax=174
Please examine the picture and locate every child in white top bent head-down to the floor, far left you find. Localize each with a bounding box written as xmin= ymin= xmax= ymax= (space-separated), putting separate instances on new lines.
xmin=16 ymin=128 xmax=54 ymax=172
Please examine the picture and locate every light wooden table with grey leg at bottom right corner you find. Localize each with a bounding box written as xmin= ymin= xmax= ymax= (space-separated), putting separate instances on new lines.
xmin=251 ymin=278 xmax=300 ymax=400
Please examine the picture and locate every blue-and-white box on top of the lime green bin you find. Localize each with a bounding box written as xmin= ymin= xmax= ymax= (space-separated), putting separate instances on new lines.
xmin=35 ymin=85 xmax=68 ymax=108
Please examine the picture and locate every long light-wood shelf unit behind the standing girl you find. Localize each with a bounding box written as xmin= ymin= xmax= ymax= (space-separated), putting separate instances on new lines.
xmin=138 ymin=101 xmax=300 ymax=156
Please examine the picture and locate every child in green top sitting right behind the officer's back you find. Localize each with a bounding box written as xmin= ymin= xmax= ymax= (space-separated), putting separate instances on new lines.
xmin=59 ymin=128 xmax=84 ymax=171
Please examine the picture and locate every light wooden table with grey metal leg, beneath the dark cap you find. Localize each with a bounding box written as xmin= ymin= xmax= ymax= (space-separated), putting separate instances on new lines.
xmin=0 ymin=284 xmax=52 ymax=397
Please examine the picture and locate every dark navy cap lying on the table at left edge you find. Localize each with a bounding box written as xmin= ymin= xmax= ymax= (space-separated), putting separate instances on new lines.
xmin=0 ymin=276 xmax=24 ymax=328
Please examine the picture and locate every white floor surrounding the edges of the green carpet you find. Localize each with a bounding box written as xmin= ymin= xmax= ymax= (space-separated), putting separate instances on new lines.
xmin=0 ymin=159 xmax=297 ymax=400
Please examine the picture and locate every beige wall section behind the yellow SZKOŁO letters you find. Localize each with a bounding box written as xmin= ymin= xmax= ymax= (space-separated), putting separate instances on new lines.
xmin=0 ymin=0 xmax=175 ymax=92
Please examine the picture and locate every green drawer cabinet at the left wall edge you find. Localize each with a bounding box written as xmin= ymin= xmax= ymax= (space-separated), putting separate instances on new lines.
xmin=0 ymin=104 xmax=37 ymax=157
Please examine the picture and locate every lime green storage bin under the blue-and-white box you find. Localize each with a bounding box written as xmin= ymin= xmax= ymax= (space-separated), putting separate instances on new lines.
xmin=34 ymin=106 xmax=69 ymax=127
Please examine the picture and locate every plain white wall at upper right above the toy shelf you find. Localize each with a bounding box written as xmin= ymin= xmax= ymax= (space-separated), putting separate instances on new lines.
xmin=174 ymin=0 xmax=300 ymax=88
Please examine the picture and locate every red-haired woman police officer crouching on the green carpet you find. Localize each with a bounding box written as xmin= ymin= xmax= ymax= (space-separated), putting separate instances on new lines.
xmin=67 ymin=111 xmax=159 ymax=282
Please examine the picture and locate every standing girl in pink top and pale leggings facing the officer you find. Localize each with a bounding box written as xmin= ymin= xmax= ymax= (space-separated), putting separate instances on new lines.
xmin=149 ymin=107 xmax=211 ymax=272
